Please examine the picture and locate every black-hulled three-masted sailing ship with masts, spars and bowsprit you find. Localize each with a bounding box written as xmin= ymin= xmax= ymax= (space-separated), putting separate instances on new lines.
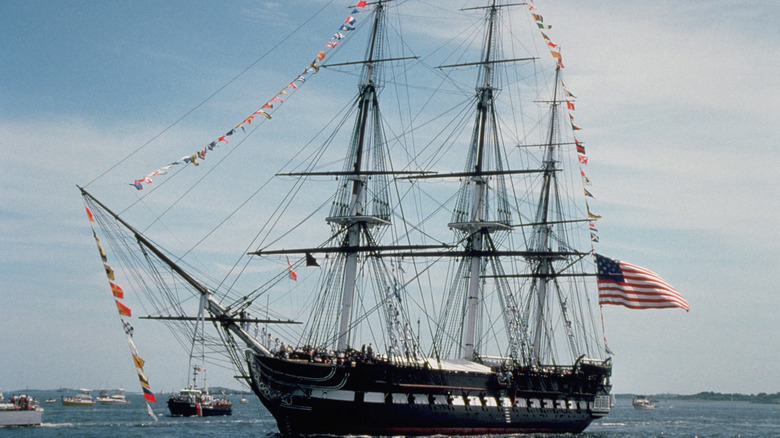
xmin=82 ymin=0 xmax=611 ymax=435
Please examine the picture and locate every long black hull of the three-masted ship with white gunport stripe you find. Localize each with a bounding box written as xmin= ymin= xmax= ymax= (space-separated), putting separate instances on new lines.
xmin=248 ymin=353 xmax=611 ymax=435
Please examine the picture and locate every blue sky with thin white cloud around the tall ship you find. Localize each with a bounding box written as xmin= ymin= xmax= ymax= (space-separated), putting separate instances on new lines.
xmin=0 ymin=0 xmax=780 ymax=394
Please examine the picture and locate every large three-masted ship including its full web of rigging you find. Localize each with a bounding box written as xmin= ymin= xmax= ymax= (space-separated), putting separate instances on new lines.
xmin=81 ymin=0 xmax=628 ymax=435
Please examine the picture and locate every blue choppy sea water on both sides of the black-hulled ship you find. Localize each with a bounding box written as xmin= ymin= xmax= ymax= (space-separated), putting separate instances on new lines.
xmin=0 ymin=391 xmax=780 ymax=438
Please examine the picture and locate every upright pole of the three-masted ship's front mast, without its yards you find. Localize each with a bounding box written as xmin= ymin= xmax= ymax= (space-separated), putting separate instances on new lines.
xmin=326 ymin=0 xmax=390 ymax=350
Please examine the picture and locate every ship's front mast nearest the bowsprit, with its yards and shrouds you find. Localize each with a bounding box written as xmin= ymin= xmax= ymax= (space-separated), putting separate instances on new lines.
xmin=250 ymin=0 xmax=430 ymax=362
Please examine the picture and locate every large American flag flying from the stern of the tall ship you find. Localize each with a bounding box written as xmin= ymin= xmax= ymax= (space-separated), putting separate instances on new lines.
xmin=596 ymin=254 xmax=690 ymax=312
